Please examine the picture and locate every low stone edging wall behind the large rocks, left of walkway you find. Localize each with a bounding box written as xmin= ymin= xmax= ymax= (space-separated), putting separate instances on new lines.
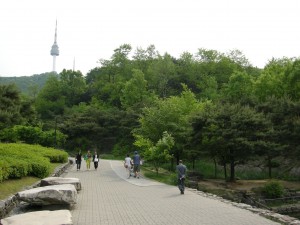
xmin=0 ymin=158 xmax=74 ymax=219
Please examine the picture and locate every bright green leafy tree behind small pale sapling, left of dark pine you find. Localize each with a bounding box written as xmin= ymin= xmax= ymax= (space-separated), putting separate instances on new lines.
xmin=133 ymin=87 xmax=201 ymax=163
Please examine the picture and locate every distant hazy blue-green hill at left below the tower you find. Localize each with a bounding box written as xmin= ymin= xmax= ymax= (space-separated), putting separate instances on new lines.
xmin=0 ymin=72 xmax=58 ymax=95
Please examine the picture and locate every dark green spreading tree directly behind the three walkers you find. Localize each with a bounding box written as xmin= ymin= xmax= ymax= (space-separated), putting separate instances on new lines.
xmin=58 ymin=101 xmax=138 ymax=152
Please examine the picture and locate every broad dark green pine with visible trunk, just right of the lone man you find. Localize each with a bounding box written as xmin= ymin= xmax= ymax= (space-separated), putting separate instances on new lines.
xmin=195 ymin=103 xmax=270 ymax=181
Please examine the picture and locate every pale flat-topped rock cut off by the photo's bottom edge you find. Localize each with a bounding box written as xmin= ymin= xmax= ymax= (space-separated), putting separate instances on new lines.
xmin=1 ymin=210 xmax=73 ymax=225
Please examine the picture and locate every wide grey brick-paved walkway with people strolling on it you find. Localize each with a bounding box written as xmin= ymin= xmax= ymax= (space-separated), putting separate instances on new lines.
xmin=65 ymin=160 xmax=279 ymax=225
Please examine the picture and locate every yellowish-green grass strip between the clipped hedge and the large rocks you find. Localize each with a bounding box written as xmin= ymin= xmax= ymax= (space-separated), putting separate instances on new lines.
xmin=0 ymin=177 xmax=40 ymax=200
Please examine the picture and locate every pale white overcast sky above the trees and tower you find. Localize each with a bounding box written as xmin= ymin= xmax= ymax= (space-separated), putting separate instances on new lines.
xmin=0 ymin=0 xmax=300 ymax=76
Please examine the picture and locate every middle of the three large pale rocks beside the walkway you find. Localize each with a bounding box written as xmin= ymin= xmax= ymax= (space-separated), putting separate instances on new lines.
xmin=16 ymin=184 xmax=77 ymax=205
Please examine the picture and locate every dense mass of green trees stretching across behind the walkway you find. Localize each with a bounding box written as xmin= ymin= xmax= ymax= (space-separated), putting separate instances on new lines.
xmin=0 ymin=44 xmax=300 ymax=180
